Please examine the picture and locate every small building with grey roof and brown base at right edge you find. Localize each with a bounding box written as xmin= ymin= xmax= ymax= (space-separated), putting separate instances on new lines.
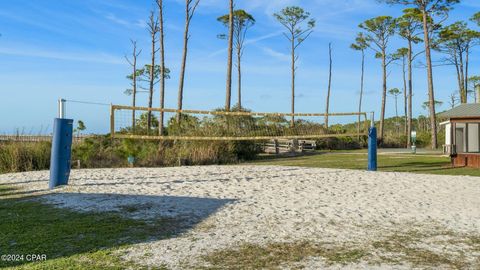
xmin=439 ymin=103 xmax=480 ymax=168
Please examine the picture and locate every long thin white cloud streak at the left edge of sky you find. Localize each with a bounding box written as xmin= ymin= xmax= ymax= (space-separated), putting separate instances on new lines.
xmin=0 ymin=46 xmax=124 ymax=65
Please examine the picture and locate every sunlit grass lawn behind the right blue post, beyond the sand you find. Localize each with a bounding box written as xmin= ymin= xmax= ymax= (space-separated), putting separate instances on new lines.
xmin=249 ymin=151 xmax=480 ymax=176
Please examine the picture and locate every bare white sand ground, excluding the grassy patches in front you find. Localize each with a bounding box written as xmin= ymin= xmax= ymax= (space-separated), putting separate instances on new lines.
xmin=0 ymin=166 xmax=480 ymax=269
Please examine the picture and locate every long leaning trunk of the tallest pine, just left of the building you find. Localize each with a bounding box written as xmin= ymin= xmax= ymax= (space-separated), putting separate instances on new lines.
xmin=422 ymin=7 xmax=438 ymax=149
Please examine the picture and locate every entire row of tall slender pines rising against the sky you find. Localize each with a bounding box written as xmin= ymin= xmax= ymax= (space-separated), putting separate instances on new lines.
xmin=126 ymin=0 xmax=480 ymax=148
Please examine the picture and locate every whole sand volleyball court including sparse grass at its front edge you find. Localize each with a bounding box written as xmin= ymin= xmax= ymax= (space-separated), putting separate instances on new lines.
xmin=1 ymin=166 xmax=480 ymax=269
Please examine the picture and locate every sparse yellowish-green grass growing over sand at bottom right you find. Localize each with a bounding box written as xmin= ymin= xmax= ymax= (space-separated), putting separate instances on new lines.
xmin=203 ymin=226 xmax=480 ymax=269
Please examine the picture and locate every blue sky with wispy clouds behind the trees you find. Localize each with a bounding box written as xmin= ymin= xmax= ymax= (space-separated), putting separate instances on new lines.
xmin=0 ymin=0 xmax=480 ymax=133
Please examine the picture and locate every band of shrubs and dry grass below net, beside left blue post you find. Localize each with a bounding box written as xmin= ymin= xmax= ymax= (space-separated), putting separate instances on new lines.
xmin=72 ymin=137 xmax=259 ymax=168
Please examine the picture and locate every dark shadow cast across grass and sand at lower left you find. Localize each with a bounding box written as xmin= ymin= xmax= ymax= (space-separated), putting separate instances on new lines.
xmin=0 ymin=193 xmax=233 ymax=269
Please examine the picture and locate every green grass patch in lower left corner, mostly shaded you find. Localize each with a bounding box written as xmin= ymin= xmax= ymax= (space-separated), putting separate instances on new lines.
xmin=0 ymin=185 xmax=176 ymax=269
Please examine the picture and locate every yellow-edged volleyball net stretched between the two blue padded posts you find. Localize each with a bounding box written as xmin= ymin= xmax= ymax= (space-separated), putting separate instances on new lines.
xmin=110 ymin=105 xmax=369 ymax=141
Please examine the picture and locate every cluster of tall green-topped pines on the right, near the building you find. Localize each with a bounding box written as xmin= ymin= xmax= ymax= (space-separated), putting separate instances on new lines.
xmin=351 ymin=0 xmax=480 ymax=148
